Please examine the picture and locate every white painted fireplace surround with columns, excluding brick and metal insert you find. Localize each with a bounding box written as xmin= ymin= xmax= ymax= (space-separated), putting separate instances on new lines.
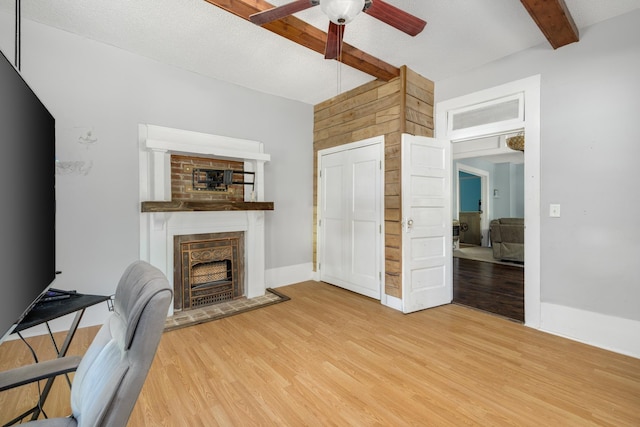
xmin=139 ymin=125 xmax=270 ymax=316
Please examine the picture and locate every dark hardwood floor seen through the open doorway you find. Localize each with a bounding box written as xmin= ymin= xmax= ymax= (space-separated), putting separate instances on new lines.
xmin=453 ymin=257 xmax=524 ymax=322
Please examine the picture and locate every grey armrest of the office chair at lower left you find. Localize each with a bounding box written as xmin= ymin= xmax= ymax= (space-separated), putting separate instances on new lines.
xmin=0 ymin=356 xmax=82 ymax=391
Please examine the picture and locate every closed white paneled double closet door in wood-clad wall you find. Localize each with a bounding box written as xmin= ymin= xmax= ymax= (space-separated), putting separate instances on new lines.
xmin=319 ymin=144 xmax=382 ymax=299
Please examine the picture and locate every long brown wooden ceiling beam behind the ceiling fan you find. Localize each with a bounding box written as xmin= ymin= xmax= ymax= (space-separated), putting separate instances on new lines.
xmin=205 ymin=0 xmax=400 ymax=81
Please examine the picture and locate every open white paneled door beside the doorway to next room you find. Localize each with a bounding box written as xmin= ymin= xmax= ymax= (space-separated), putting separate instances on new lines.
xmin=402 ymin=134 xmax=453 ymax=313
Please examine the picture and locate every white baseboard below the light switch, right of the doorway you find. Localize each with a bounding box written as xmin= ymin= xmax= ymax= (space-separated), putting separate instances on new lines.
xmin=540 ymin=303 xmax=640 ymax=358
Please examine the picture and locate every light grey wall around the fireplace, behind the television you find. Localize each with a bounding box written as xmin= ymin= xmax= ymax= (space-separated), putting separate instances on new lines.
xmin=0 ymin=13 xmax=313 ymax=332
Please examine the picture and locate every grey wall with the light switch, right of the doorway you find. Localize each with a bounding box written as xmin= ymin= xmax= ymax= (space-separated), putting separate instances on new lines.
xmin=435 ymin=10 xmax=640 ymax=356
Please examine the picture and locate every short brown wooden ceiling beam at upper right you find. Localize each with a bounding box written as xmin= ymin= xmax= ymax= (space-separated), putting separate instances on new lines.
xmin=520 ymin=0 xmax=580 ymax=49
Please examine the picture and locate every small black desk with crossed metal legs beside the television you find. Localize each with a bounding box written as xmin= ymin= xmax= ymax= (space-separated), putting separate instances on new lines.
xmin=5 ymin=293 xmax=110 ymax=426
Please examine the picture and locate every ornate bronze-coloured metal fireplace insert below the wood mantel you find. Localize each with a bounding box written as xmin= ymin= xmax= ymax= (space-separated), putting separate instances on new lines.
xmin=173 ymin=232 xmax=244 ymax=311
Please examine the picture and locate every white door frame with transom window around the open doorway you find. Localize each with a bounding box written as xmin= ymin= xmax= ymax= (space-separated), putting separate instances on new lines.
xmin=435 ymin=75 xmax=541 ymax=328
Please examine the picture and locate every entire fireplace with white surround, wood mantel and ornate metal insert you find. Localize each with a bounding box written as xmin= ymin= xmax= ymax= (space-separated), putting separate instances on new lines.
xmin=139 ymin=125 xmax=273 ymax=315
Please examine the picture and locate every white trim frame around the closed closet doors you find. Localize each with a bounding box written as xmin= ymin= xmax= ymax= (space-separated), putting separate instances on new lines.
xmin=314 ymin=136 xmax=387 ymax=305
